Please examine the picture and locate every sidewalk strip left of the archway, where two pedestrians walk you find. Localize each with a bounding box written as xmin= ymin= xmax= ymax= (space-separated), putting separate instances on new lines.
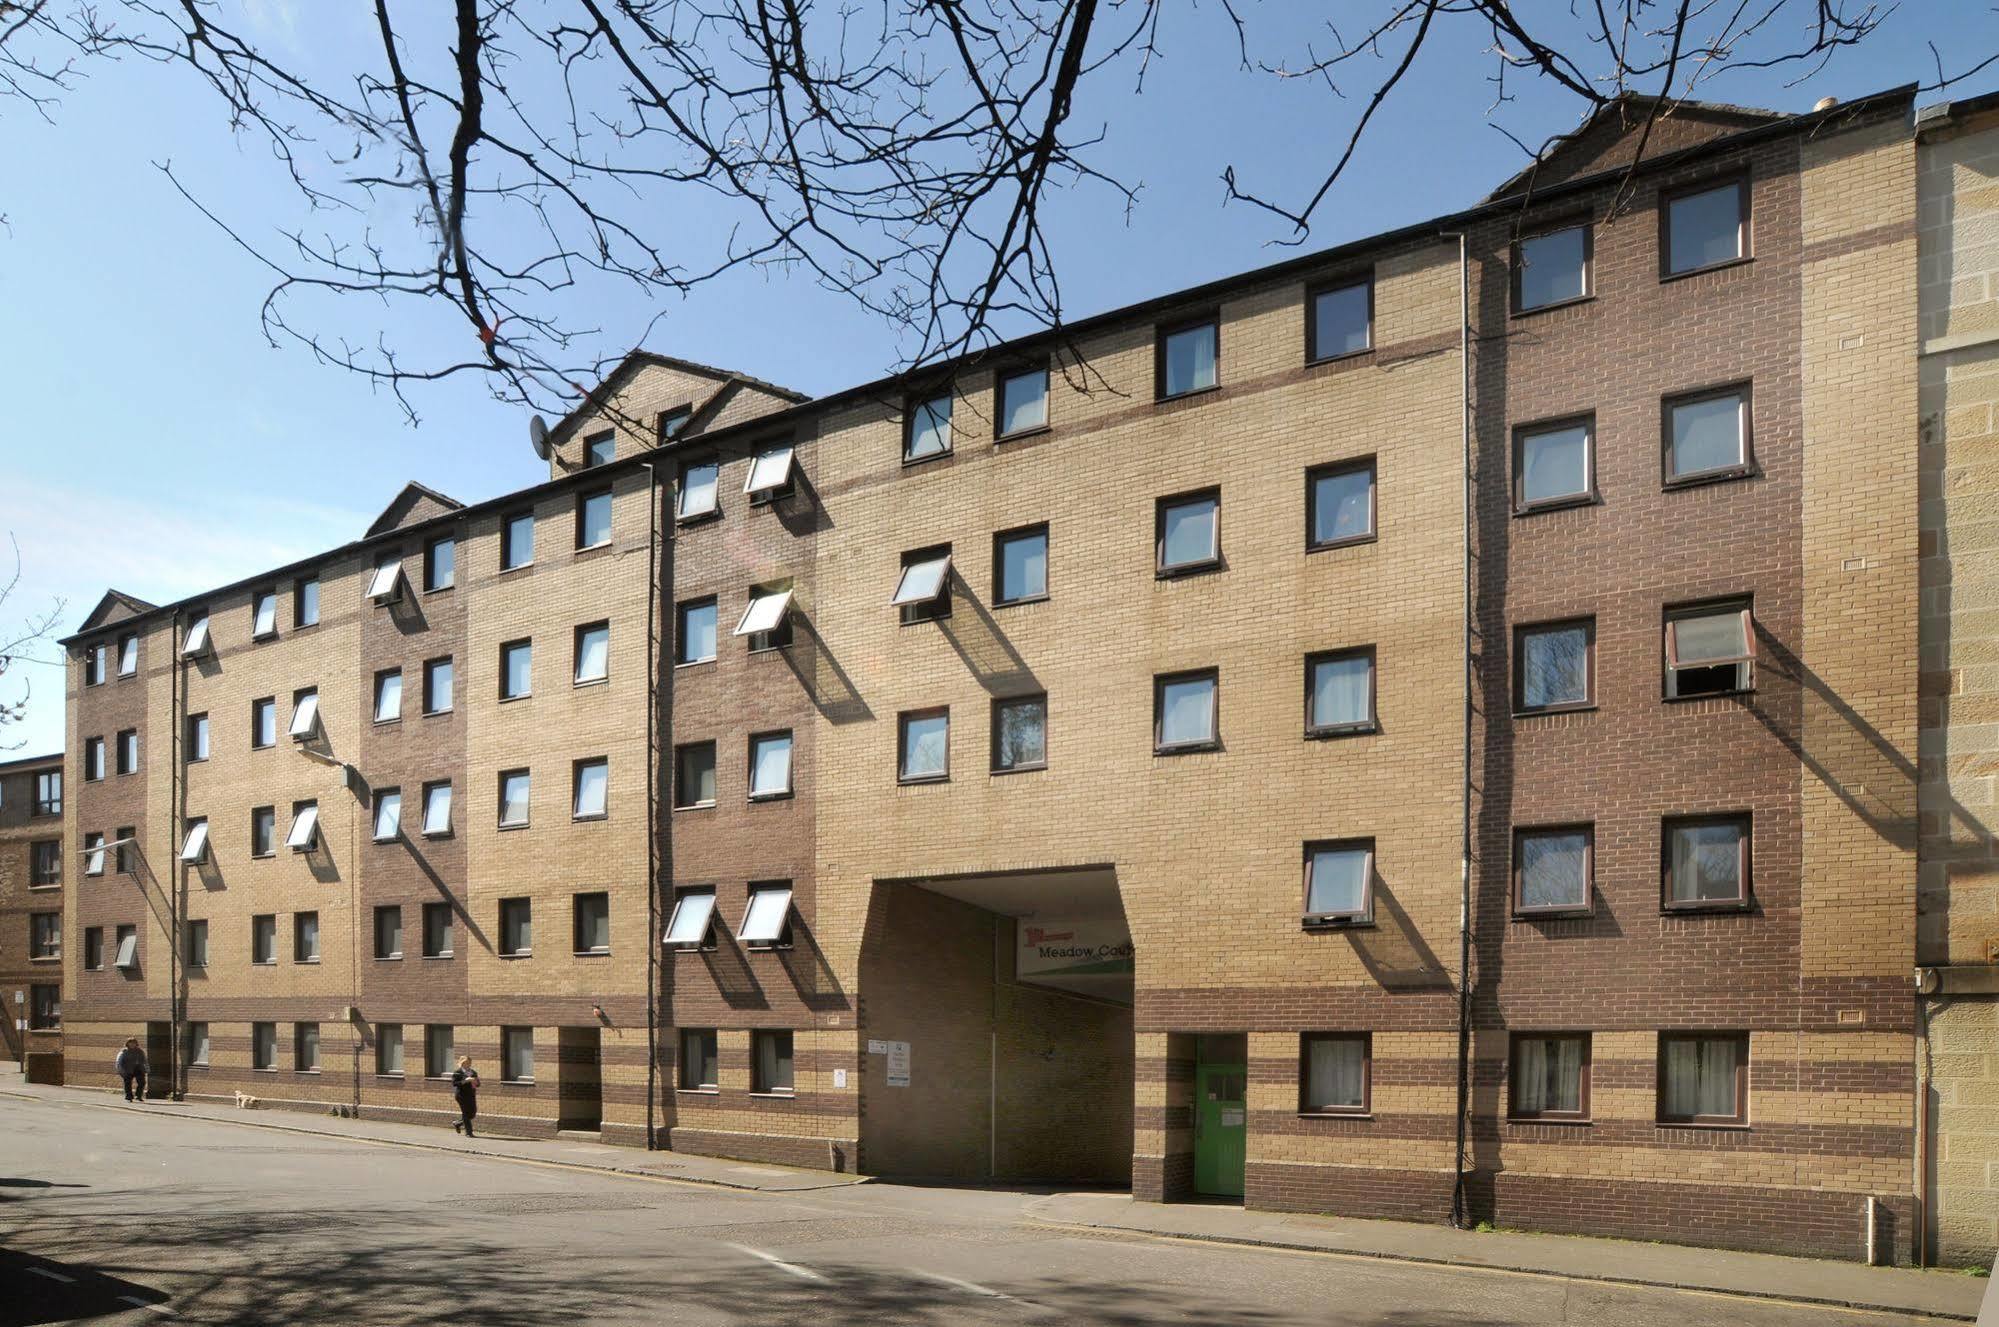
xmin=0 ymin=1075 xmax=868 ymax=1193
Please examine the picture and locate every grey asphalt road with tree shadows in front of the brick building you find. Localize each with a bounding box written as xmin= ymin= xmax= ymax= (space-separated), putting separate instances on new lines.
xmin=0 ymin=1099 xmax=1933 ymax=1327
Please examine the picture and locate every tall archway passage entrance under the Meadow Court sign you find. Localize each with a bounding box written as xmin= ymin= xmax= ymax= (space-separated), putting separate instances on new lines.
xmin=860 ymin=867 xmax=1135 ymax=1185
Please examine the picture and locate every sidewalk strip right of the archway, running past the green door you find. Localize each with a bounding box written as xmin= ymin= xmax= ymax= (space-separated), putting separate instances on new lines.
xmin=1027 ymin=1193 xmax=1999 ymax=1321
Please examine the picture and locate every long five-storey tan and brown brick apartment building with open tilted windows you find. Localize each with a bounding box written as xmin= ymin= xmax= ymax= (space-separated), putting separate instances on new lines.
xmin=64 ymin=88 xmax=1917 ymax=1259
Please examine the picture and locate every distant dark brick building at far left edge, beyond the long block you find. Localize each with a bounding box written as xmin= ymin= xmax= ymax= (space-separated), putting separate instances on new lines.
xmin=0 ymin=755 xmax=68 ymax=1083
